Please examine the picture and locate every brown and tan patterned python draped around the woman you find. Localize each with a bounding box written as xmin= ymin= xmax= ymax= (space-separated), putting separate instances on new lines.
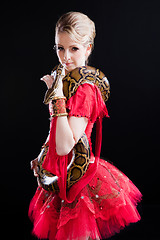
xmin=38 ymin=64 xmax=110 ymax=192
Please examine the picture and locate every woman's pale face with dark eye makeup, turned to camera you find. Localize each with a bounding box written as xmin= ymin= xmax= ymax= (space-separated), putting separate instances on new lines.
xmin=55 ymin=32 xmax=91 ymax=73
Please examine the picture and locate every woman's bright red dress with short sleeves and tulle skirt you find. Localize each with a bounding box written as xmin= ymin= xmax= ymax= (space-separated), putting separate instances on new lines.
xmin=29 ymin=83 xmax=142 ymax=240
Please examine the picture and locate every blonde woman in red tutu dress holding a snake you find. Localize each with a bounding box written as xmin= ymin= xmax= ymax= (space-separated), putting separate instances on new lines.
xmin=29 ymin=12 xmax=141 ymax=240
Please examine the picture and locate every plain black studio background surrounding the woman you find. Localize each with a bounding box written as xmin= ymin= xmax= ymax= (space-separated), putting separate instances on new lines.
xmin=0 ymin=0 xmax=160 ymax=240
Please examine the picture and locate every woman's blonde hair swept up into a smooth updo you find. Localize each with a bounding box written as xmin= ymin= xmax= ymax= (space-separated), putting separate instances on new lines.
xmin=55 ymin=12 xmax=96 ymax=50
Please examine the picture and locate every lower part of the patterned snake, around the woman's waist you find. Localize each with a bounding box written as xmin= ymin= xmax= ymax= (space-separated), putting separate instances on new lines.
xmin=38 ymin=133 xmax=90 ymax=191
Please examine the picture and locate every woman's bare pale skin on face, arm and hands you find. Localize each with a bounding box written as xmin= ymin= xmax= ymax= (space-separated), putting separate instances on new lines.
xmin=31 ymin=32 xmax=91 ymax=177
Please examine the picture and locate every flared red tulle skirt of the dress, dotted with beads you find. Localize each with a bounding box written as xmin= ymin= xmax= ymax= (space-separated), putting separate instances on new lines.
xmin=29 ymin=159 xmax=142 ymax=240
